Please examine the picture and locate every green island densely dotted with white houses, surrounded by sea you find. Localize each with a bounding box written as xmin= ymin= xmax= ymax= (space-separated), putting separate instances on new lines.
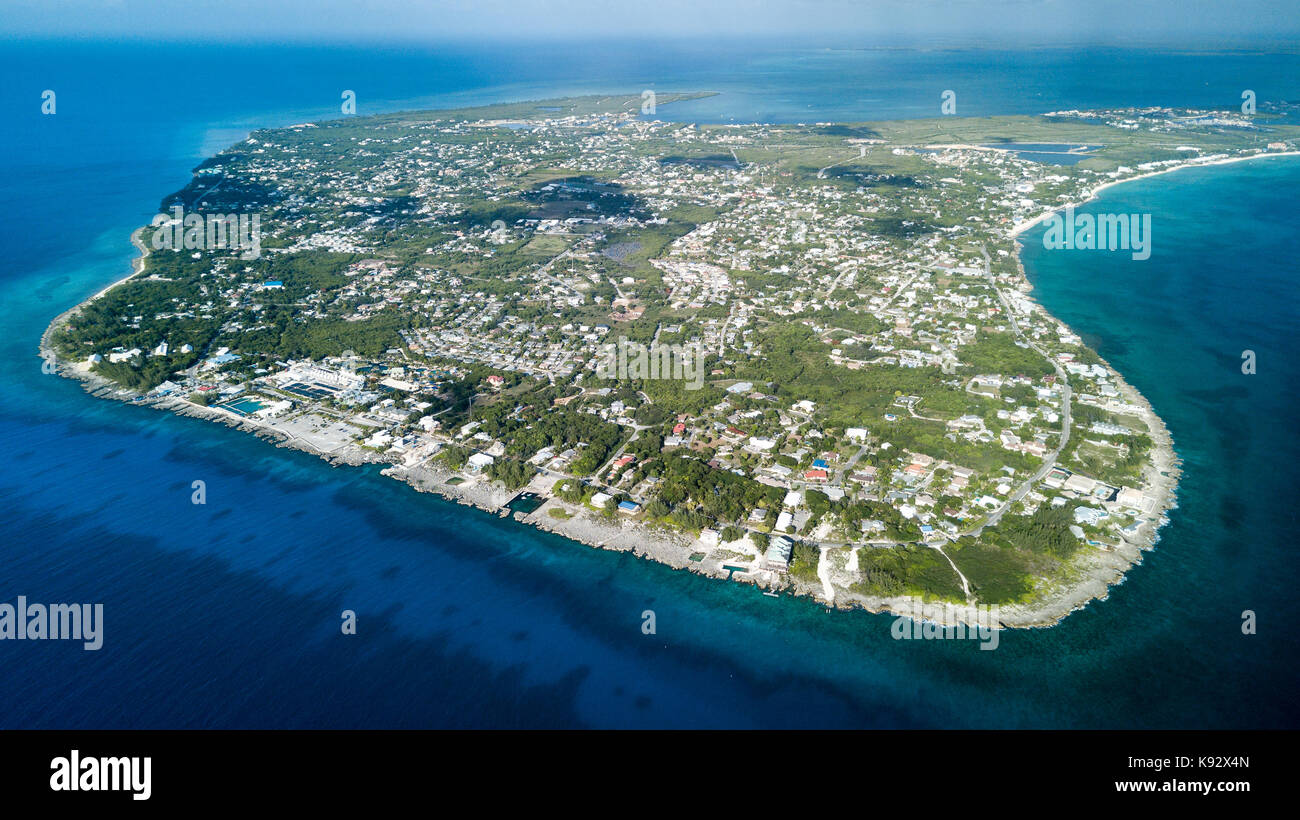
xmin=39 ymin=92 xmax=1300 ymax=628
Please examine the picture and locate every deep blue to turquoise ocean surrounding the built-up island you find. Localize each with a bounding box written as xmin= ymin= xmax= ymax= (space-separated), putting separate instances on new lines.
xmin=0 ymin=42 xmax=1300 ymax=728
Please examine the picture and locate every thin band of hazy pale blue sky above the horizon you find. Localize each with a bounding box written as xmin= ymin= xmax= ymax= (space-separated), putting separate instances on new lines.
xmin=10 ymin=0 xmax=1300 ymax=44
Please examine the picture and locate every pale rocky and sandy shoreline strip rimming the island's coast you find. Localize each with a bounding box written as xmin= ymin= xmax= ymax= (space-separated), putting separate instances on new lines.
xmin=39 ymin=151 xmax=1300 ymax=629
